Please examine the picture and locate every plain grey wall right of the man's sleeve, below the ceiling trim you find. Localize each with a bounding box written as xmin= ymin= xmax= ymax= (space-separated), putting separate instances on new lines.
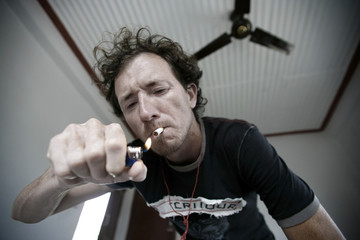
xmin=269 ymin=66 xmax=360 ymax=239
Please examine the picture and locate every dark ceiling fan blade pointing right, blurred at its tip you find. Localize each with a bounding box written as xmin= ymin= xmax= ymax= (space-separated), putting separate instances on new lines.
xmin=250 ymin=28 xmax=294 ymax=54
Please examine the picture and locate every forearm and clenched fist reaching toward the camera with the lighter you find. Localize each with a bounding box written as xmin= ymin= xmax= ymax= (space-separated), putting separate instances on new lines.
xmin=12 ymin=119 xmax=135 ymax=223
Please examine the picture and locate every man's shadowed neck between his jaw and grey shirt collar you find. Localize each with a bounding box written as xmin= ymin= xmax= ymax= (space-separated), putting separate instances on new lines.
xmin=166 ymin=121 xmax=202 ymax=166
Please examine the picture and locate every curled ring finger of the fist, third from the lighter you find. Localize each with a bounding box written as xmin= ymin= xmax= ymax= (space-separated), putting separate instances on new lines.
xmin=64 ymin=124 xmax=90 ymax=180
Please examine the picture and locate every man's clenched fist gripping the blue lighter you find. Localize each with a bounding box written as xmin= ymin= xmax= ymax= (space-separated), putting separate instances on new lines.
xmin=47 ymin=119 xmax=147 ymax=188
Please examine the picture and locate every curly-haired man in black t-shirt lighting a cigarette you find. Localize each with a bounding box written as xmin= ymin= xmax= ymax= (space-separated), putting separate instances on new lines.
xmin=13 ymin=28 xmax=343 ymax=239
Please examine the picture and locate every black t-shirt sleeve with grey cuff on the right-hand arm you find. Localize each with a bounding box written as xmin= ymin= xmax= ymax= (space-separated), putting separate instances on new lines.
xmin=238 ymin=126 xmax=319 ymax=227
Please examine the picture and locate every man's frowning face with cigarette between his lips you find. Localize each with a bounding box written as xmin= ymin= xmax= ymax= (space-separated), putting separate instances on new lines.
xmin=115 ymin=53 xmax=197 ymax=156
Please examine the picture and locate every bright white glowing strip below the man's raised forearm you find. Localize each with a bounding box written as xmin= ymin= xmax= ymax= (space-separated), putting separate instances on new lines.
xmin=72 ymin=193 xmax=110 ymax=240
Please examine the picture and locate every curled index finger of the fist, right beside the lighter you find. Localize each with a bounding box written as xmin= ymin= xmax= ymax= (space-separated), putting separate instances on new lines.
xmin=105 ymin=123 xmax=127 ymax=176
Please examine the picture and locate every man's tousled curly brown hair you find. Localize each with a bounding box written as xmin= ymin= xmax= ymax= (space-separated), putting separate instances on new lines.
xmin=93 ymin=27 xmax=207 ymax=120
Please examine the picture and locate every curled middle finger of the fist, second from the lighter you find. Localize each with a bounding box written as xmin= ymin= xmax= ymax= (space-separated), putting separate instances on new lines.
xmin=85 ymin=119 xmax=108 ymax=179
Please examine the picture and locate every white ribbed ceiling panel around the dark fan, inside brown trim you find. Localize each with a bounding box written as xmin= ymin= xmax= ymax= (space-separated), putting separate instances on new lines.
xmin=44 ymin=0 xmax=360 ymax=134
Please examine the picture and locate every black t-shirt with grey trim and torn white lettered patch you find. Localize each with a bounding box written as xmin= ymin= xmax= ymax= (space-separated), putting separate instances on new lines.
xmin=112 ymin=117 xmax=319 ymax=240
